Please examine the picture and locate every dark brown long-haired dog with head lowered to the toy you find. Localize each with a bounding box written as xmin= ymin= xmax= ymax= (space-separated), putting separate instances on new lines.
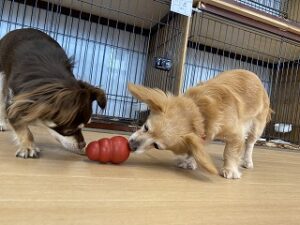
xmin=0 ymin=29 xmax=106 ymax=158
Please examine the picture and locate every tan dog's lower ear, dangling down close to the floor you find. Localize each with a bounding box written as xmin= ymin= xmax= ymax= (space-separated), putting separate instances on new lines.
xmin=184 ymin=134 xmax=218 ymax=174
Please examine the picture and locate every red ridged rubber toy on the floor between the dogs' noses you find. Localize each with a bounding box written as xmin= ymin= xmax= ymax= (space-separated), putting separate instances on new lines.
xmin=85 ymin=136 xmax=130 ymax=164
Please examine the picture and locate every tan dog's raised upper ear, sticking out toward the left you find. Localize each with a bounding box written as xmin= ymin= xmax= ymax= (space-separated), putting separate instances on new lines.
xmin=128 ymin=83 xmax=167 ymax=112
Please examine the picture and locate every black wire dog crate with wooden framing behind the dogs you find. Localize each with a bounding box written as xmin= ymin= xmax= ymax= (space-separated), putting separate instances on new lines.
xmin=0 ymin=0 xmax=300 ymax=144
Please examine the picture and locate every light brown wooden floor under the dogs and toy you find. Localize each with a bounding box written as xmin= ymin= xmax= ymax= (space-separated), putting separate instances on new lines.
xmin=0 ymin=129 xmax=300 ymax=225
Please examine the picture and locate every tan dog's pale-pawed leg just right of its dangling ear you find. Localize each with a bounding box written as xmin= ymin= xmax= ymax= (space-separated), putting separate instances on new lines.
xmin=221 ymin=138 xmax=244 ymax=179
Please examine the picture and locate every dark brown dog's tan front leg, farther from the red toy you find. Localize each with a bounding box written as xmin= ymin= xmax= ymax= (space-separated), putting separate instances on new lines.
xmin=11 ymin=124 xmax=40 ymax=159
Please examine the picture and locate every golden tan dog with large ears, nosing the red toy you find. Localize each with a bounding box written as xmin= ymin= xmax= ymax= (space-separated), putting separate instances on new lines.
xmin=128 ymin=70 xmax=272 ymax=179
